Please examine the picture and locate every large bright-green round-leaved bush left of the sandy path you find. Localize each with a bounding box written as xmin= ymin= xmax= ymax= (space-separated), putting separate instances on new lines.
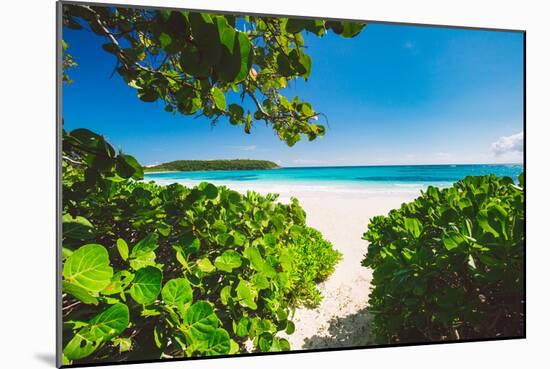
xmin=62 ymin=129 xmax=340 ymax=364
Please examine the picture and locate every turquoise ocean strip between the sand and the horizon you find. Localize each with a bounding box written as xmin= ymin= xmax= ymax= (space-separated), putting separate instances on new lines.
xmin=145 ymin=164 xmax=523 ymax=193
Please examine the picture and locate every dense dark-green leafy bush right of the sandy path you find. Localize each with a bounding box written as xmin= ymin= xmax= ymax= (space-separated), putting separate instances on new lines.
xmin=363 ymin=175 xmax=525 ymax=343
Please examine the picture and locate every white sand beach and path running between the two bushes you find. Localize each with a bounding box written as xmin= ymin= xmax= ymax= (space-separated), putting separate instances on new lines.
xmin=153 ymin=180 xmax=420 ymax=350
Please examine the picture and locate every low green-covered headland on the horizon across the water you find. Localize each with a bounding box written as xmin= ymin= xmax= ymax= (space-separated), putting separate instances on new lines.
xmin=143 ymin=159 xmax=279 ymax=172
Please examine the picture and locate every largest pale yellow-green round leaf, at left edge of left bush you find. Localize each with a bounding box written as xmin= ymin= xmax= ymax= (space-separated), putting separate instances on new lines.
xmin=63 ymin=244 xmax=113 ymax=292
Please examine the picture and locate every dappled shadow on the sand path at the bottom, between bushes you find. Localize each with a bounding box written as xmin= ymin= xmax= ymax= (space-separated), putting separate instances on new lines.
xmin=302 ymin=308 xmax=374 ymax=349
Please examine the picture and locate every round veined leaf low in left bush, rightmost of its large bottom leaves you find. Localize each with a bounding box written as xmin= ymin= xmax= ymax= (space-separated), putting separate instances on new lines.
xmin=184 ymin=301 xmax=219 ymax=341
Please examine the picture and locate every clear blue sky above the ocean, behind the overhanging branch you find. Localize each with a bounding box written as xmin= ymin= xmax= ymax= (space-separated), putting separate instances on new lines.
xmin=63 ymin=18 xmax=523 ymax=166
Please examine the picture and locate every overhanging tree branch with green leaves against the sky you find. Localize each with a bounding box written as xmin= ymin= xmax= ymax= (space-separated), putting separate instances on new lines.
xmin=63 ymin=4 xmax=365 ymax=146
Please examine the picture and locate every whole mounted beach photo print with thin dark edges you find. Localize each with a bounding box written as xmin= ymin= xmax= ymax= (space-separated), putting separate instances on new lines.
xmin=57 ymin=2 xmax=525 ymax=367
